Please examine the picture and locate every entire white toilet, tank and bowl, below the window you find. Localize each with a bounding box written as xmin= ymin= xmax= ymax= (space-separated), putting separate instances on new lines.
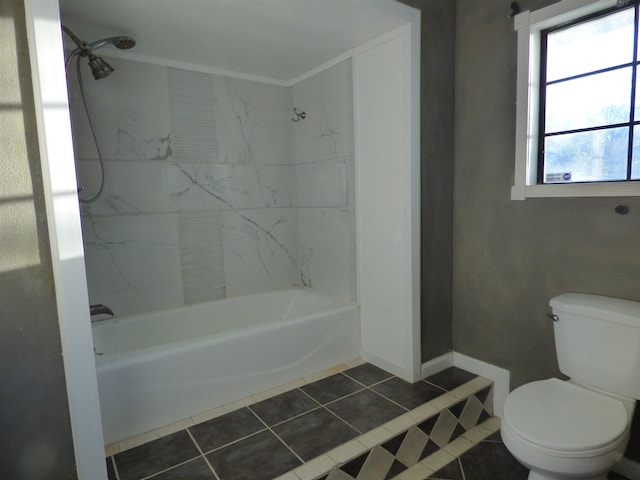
xmin=501 ymin=293 xmax=640 ymax=480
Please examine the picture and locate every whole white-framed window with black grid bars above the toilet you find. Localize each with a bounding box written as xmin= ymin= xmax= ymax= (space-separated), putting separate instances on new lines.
xmin=511 ymin=0 xmax=640 ymax=199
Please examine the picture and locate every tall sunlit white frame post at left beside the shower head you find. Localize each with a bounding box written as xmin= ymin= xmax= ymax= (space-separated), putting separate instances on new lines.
xmin=25 ymin=0 xmax=107 ymax=480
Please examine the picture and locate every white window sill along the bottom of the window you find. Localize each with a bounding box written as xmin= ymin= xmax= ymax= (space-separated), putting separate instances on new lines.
xmin=511 ymin=182 xmax=640 ymax=200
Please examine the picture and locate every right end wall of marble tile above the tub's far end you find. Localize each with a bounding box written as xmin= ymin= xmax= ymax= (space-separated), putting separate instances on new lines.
xmin=293 ymin=60 xmax=357 ymax=302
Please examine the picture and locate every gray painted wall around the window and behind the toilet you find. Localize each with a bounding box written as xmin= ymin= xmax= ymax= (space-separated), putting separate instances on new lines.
xmin=453 ymin=0 xmax=640 ymax=460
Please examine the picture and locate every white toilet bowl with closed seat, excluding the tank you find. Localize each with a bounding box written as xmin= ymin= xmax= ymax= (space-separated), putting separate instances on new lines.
xmin=501 ymin=378 xmax=633 ymax=480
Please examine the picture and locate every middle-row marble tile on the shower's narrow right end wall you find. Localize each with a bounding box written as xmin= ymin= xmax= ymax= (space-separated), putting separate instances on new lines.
xmin=296 ymin=159 xmax=348 ymax=207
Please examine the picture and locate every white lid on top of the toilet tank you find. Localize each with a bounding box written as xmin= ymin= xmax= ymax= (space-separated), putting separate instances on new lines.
xmin=549 ymin=293 xmax=640 ymax=328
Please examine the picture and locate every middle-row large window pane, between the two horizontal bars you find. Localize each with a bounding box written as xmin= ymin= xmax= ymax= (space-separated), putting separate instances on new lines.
xmin=545 ymin=67 xmax=631 ymax=133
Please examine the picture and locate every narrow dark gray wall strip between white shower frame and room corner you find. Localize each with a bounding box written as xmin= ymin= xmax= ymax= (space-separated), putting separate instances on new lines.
xmin=402 ymin=0 xmax=456 ymax=362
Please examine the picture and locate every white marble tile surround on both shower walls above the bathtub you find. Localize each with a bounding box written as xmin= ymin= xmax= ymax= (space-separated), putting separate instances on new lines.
xmin=69 ymin=58 xmax=357 ymax=315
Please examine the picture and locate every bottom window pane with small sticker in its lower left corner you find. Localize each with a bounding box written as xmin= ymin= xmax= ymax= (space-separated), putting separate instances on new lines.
xmin=543 ymin=127 xmax=629 ymax=183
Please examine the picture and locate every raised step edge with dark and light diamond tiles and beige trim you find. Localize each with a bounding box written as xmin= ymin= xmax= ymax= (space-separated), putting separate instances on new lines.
xmin=277 ymin=377 xmax=499 ymax=480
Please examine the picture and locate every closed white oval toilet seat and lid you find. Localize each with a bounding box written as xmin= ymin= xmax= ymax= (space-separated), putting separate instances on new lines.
xmin=503 ymin=378 xmax=628 ymax=457
